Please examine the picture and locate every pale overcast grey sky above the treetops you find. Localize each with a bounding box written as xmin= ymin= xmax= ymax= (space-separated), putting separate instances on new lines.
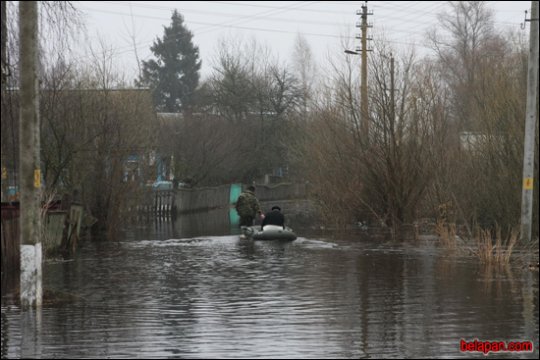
xmin=75 ymin=1 xmax=531 ymax=78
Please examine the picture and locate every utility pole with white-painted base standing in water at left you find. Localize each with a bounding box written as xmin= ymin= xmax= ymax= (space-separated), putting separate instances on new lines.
xmin=19 ymin=1 xmax=43 ymax=309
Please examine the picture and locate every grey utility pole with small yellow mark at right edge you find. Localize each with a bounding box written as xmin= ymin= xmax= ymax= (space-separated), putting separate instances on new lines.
xmin=521 ymin=1 xmax=538 ymax=242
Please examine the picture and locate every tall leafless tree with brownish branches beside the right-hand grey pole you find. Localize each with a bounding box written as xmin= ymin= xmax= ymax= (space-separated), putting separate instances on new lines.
xmin=430 ymin=1 xmax=526 ymax=236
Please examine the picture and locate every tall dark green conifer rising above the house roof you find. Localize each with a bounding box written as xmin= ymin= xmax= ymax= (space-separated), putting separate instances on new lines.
xmin=138 ymin=10 xmax=201 ymax=112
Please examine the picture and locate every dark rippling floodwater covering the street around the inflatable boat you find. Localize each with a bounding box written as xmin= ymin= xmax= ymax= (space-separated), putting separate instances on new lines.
xmin=1 ymin=204 xmax=539 ymax=359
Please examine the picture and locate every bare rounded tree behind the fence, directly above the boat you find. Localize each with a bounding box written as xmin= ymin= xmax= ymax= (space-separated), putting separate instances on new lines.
xmin=192 ymin=40 xmax=301 ymax=182
